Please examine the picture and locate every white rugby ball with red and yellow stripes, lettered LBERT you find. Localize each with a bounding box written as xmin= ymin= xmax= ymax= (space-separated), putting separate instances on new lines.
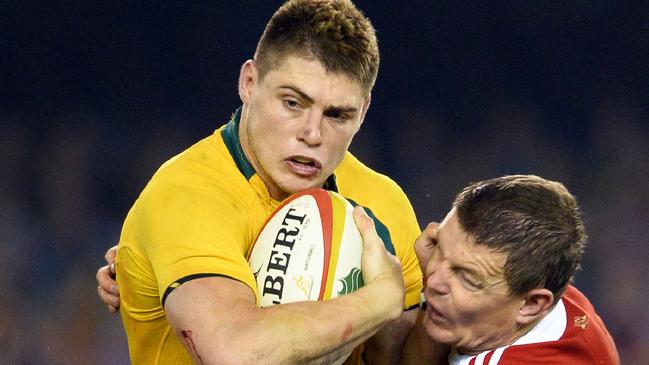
xmin=248 ymin=189 xmax=363 ymax=307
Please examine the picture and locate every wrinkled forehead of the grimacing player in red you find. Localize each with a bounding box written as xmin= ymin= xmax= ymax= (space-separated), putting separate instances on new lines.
xmin=437 ymin=208 xmax=507 ymax=277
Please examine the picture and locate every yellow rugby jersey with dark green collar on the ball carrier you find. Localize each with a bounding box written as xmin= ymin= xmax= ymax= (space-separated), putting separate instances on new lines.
xmin=116 ymin=110 xmax=422 ymax=364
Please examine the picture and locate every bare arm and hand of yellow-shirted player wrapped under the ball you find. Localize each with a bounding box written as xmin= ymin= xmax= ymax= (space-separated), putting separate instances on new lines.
xmin=165 ymin=208 xmax=404 ymax=364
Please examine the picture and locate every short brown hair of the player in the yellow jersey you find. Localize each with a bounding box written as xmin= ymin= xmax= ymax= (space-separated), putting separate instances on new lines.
xmin=255 ymin=0 xmax=379 ymax=93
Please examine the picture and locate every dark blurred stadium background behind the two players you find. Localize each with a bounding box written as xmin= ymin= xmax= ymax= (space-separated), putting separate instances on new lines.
xmin=0 ymin=0 xmax=649 ymax=364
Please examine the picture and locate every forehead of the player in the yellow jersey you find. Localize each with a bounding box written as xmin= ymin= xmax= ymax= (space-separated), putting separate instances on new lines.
xmin=262 ymin=55 xmax=367 ymax=103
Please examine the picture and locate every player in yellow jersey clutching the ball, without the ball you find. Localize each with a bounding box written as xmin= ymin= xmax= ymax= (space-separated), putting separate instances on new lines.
xmin=97 ymin=0 xmax=422 ymax=364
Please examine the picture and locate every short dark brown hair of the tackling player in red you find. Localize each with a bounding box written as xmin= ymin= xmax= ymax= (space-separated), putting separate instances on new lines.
xmin=453 ymin=175 xmax=586 ymax=301
